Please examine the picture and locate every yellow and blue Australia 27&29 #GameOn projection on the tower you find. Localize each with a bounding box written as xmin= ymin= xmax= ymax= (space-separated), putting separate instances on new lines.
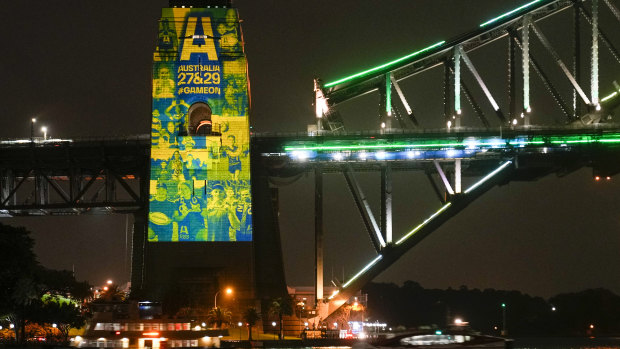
xmin=148 ymin=8 xmax=252 ymax=242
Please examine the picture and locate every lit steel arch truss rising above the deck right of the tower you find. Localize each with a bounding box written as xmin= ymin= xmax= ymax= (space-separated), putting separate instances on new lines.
xmin=315 ymin=0 xmax=620 ymax=132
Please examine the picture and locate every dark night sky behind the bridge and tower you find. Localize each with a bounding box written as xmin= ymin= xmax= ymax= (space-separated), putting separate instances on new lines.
xmin=0 ymin=0 xmax=620 ymax=297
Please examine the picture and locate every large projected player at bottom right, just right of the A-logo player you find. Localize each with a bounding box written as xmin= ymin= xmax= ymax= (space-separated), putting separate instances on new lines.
xmin=202 ymin=184 xmax=239 ymax=241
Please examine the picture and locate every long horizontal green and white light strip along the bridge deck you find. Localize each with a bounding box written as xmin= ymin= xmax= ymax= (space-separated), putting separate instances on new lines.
xmin=284 ymin=133 xmax=620 ymax=152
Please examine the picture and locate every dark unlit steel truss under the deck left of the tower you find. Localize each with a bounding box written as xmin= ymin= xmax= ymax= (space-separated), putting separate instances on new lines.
xmin=0 ymin=138 xmax=150 ymax=216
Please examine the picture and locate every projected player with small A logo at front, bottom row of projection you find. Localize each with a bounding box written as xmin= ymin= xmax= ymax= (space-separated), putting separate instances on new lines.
xmin=172 ymin=182 xmax=206 ymax=241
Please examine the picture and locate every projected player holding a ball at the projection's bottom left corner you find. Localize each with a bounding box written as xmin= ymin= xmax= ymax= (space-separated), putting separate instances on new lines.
xmin=148 ymin=182 xmax=175 ymax=241
